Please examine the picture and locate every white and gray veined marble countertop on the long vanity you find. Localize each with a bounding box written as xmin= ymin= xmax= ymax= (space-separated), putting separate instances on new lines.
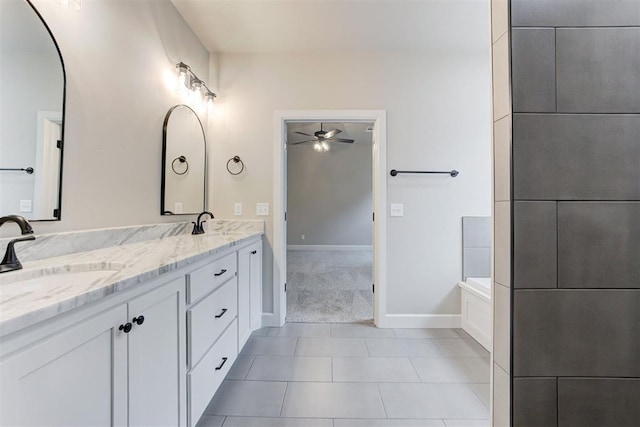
xmin=0 ymin=227 xmax=263 ymax=336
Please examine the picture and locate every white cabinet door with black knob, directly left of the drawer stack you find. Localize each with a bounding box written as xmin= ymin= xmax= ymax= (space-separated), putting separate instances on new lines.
xmin=128 ymin=278 xmax=186 ymax=427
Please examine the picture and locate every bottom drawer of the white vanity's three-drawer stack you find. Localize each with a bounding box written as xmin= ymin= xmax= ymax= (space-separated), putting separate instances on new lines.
xmin=187 ymin=320 xmax=238 ymax=427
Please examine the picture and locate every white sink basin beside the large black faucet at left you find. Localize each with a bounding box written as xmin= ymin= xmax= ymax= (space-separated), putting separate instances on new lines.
xmin=0 ymin=262 xmax=125 ymax=297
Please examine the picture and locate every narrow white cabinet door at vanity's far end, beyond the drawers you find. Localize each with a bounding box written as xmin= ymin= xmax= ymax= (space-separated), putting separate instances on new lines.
xmin=238 ymin=241 xmax=262 ymax=351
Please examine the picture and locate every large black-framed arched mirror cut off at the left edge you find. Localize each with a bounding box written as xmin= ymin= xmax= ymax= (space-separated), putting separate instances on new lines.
xmin=0 ymin=0 xmax=66 ymax=220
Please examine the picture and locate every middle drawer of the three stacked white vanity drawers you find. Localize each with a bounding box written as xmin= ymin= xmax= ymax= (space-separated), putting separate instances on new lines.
xmin=187 ymin=277 xmax=238 ymax=367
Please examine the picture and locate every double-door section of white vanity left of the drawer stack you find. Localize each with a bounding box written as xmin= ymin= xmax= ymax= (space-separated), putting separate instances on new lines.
xmin=0 ymin=277 xmax=186 ymax=427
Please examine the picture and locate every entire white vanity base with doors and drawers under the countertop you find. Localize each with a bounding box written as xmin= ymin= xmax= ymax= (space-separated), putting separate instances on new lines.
xmin=0 ymin=234 xmax=262 ymax=427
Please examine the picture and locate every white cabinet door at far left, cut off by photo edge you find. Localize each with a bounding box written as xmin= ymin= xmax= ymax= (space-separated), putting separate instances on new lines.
xmin=0 ymin=305 xmax=127 ymax=427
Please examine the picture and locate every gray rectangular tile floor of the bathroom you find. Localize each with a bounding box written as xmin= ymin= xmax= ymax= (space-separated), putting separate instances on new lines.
xmin=198 ymin=323 xmax=489 ymax=427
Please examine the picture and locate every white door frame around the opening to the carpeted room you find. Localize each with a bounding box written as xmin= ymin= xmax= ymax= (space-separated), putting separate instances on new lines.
xmin=273 ymin=110 xmax=387 ymax=327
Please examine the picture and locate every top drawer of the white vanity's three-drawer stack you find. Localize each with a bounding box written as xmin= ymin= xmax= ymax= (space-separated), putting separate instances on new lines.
xmin=187 ymin=252 xmax=238 ymax=304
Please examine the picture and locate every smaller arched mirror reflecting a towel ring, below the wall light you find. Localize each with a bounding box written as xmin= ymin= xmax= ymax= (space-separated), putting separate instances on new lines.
xmin=160 ymin=105 xmax=207 ymax=215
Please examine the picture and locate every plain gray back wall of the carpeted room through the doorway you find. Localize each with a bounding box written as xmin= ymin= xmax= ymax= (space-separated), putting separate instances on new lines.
xmin=287 ymin=134 xmax=373 ymax=245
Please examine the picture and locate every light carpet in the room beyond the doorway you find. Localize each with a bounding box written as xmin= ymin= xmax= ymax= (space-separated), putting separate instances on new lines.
xmin=287 ymin=250 xmax=373 ymax=323
